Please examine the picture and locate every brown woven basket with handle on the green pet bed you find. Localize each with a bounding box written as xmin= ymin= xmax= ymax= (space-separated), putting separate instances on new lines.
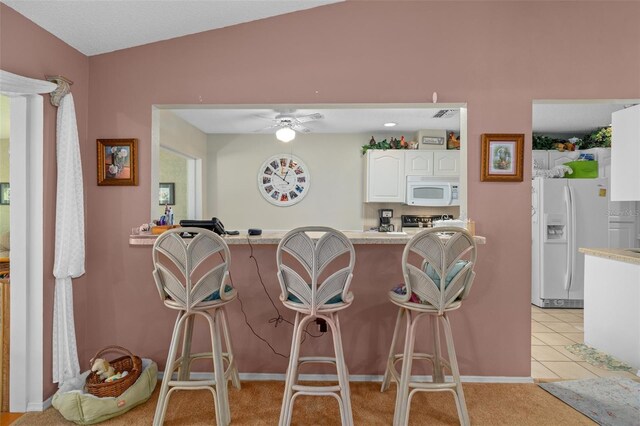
xmin=86 ymin=346 xmax=142 ymax=398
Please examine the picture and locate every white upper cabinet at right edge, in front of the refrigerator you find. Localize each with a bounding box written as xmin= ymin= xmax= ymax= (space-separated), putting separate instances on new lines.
xmin=611 ymin=105 xmax=640 ymax=201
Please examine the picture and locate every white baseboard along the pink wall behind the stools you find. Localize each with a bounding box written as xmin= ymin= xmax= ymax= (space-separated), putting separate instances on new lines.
xmin=158 ymin=371 xmax=533 ymax=383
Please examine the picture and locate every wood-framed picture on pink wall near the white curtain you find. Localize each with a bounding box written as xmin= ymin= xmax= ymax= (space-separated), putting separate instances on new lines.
xmin=97 ymin=139 xmax=138 ymax=186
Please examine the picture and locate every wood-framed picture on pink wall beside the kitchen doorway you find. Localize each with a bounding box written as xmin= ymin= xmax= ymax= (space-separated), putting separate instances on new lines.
xmin=480 ymin=133 xmax=524 ymax=182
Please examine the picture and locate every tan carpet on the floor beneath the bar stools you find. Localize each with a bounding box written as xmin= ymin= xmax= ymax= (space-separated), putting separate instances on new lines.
xmin=13 ymin=382 xmax=595 ymax=426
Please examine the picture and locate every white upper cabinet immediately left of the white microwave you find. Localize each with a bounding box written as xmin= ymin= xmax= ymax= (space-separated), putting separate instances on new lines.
xmin=365 ymin=150 xmax=406 ymax=203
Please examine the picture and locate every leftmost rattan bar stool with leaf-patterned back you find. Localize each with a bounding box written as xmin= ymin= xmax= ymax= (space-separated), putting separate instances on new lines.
xmin=153 ymin=228 xmax=240 ymax=426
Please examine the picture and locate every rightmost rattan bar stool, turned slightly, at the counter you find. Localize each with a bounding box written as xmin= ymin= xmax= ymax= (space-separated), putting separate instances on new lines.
xmin=381 ymin=227 xmax=476 ymax=426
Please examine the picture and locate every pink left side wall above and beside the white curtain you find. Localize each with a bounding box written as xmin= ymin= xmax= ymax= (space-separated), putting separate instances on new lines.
xmin=0 ymin=4 xmax=95 ymax=400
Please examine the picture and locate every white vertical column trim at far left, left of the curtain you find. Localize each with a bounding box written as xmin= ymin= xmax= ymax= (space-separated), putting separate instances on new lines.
xmin=9 ymin=95 xmax=44 ymax=412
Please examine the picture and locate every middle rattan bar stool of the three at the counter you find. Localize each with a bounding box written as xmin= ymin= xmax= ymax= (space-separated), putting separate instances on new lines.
xmin=276 ymin=227 xmax=355 ymax=426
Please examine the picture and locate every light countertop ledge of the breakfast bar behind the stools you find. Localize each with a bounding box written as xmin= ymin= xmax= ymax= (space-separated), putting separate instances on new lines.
xmin=129 ymin=231 xmax=486 ymax=246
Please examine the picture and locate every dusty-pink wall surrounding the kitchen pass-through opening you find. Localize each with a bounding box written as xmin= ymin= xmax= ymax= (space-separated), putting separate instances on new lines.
xmin=1 ymin=1 xmax=640 ymax=402
